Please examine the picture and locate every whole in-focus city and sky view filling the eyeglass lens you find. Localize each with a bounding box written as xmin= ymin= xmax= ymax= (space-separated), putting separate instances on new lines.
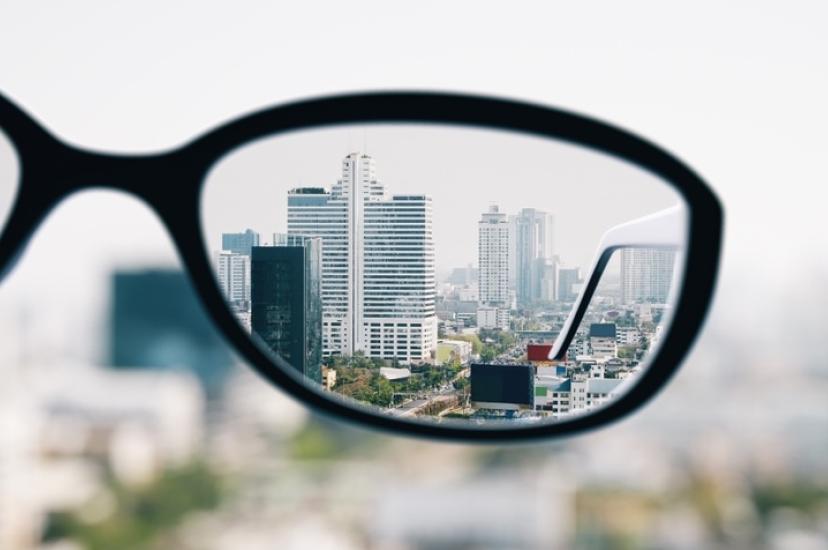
xmin=203 ymin=124 xmax=681 ymax=426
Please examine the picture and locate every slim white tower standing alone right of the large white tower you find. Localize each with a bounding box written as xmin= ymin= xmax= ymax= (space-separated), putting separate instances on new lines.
xmin=477 ymin=206 xmax=511 ymax=330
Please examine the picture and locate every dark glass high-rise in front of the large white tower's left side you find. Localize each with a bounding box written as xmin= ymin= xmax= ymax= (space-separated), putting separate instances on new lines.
xmin=250 ymin=236 xmax=322 ymax=383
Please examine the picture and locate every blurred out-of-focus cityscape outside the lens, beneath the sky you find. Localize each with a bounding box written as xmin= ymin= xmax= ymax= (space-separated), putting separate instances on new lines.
xmin=0 ymin=256 xmax=828 ymax=549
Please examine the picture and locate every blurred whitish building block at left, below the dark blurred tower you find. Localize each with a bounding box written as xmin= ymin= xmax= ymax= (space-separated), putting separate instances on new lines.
xmin=0 ymin=363 xmax=205 ymax=549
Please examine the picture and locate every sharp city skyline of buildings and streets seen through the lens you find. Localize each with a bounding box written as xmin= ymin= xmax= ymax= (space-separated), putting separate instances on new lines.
xmin=207 ymin=141 xmax=674 ymax=422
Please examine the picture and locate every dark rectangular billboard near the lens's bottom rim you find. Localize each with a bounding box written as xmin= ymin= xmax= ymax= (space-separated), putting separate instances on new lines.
xmin=471 ymin=363 xmax=535 ymax=409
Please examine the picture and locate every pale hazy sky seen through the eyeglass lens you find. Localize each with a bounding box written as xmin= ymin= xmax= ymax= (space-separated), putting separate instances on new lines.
xmin=202 ymin=124 xmax=681 ymax=271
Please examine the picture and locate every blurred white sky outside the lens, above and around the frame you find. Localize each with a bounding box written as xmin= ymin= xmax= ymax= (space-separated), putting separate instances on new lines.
xmin=0 ymin=0 xmax=828 ymax=370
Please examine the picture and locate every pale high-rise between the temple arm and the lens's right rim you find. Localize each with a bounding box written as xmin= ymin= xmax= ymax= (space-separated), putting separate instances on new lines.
xmin=621 ymin=248 xmax=676 ymax=304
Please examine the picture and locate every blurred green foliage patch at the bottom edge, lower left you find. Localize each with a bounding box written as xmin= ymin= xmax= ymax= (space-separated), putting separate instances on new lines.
xmin=43 ymin=462 xmax=223 ymax=550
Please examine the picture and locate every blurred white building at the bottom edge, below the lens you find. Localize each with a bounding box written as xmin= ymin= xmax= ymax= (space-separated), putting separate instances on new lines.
xmin=370 ymin=470 xmax=575 ymax=550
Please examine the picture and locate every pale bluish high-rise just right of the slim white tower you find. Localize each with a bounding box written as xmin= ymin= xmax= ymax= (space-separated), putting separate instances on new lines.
xmin=512 ymin=208 xmax=553 ymax=305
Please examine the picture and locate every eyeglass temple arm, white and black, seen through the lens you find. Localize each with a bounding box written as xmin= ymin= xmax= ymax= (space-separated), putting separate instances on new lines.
xmin=549 ymin=206 xmax=687 ymax=361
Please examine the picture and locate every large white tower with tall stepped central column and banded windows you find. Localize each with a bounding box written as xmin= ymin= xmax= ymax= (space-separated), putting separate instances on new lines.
xmin=288 ymin=153 xmax=437 ymax=362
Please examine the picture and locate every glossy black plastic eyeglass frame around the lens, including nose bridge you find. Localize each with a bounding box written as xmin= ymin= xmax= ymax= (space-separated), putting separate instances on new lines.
xmin=0 ymin=92 xmax=723 ymax=442
